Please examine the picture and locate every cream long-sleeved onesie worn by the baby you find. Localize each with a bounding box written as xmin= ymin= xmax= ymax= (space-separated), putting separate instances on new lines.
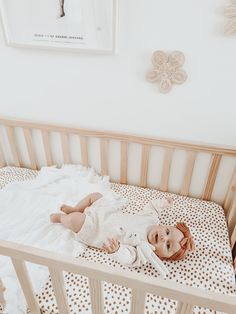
xmin=76 ymin=196 xmax=169 ymax=267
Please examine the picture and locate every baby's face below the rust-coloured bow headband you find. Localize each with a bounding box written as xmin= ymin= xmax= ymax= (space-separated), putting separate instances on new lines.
xmin=147 ymin=225 xmax=184 ymax=258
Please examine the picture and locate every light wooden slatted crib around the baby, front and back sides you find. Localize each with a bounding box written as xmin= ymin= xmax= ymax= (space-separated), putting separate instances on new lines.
xmin=0 ymin=119 xmax=236 ymax=314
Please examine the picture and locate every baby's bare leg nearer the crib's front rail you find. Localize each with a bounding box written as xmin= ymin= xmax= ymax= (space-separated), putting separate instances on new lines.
xmin=50 ymin=212 xmax=86 ymax=233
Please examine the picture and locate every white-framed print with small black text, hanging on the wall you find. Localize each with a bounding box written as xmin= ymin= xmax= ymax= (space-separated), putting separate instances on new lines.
xmin=0 ymin=0 xmax=118 ymax=54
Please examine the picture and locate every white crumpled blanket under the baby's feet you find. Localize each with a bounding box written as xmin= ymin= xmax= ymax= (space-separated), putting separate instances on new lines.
xmin=0 ymin=165 xmax=121 ymax=314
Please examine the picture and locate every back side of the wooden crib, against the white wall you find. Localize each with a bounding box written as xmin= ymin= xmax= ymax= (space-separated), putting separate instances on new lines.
xmin=0 ymin=119 xmax=236 ymax=235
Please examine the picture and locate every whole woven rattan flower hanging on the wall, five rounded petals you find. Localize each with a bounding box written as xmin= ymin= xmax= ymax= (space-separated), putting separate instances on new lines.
xmin=147 ymin=51 xmax=187 ymax=93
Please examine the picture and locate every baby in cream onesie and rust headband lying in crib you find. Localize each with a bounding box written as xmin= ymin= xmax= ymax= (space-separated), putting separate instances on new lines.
xmin=50 ymin=193 xmax=194 ymax=266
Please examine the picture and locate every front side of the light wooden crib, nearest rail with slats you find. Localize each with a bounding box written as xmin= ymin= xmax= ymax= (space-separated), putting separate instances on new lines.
xmin=0 ymin=241 xmax=236 ymax=314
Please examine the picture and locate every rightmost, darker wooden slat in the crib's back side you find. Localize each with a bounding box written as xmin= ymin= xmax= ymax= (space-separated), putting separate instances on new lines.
xmin=202 ymin=154 xmax=222 ymax=201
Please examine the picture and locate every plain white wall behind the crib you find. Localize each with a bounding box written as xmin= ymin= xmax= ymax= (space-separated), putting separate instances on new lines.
xmin=0 ymin=0 xmax=236 ymax=145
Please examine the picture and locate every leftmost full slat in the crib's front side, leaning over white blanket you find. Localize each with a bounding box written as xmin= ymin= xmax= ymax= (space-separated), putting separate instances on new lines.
xmin=11 ymin=258 xmax=41 ymax=314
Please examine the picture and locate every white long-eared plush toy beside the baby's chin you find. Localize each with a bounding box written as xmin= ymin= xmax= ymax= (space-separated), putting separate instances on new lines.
xmin=121 ymin=228 xmax=169 ymax=277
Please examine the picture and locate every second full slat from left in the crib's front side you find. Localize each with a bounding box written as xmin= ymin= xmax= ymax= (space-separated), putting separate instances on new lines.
xmin=48 ymin=267 xmax=70 ymax=314
